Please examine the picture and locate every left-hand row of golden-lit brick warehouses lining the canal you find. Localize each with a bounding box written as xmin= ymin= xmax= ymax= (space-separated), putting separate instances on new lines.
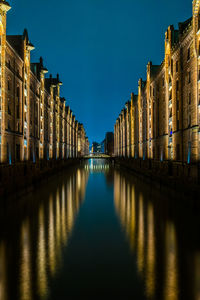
xmin=0 ymin=0 xmax=88 ymax=164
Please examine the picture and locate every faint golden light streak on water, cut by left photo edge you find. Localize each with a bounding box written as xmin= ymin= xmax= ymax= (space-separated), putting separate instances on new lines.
xmin=0 ymin=242 xmax=7 ymax=300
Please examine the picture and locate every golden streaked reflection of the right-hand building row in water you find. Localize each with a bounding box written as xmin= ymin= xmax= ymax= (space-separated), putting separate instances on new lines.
xmin=114 ymin=171 xmax=200 ymax=300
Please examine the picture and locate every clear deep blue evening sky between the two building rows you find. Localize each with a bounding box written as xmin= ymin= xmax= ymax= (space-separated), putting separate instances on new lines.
xmin=7 ymin=0 xmax=192 ymax=142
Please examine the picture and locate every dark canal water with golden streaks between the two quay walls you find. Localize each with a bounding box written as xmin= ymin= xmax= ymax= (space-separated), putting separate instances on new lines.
xmin=0 ymin=159 xmax=200 ymax=300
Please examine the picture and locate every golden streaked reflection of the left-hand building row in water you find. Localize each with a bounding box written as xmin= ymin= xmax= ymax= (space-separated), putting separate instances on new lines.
xmin=0 ymin=168 xmax=88 ymax=300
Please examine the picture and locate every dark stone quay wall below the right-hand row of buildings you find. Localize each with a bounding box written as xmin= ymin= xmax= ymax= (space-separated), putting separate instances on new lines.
xmin=114 ymin=158 xmax=200 ymax=199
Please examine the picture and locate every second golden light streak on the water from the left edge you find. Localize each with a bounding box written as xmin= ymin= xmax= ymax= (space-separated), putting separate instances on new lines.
xmin=20 ymin=220 xmax=32 ymax=300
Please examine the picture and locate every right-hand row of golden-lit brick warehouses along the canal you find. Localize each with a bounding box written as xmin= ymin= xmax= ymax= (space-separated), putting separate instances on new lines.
xmin=114 ymin=1 xmax=200 ymax=163
